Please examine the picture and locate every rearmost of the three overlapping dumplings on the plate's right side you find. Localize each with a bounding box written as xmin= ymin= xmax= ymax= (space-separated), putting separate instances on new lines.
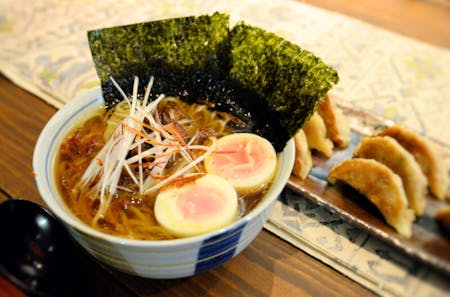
xmin=378 ymin=125 xmax=449 ymax=200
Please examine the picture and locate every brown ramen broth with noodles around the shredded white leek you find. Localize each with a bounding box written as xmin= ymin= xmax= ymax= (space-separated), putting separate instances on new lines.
xmin=56 ymin=98 xmax=269 ymax=240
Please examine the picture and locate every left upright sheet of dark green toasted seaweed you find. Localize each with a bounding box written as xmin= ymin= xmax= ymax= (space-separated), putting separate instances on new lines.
xmin=88 ymin=13 xmax=229 ymax=107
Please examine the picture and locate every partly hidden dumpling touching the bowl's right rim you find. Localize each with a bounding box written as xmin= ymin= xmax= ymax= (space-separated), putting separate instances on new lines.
xmin=292 ymin=129 xmax=313 ymax=180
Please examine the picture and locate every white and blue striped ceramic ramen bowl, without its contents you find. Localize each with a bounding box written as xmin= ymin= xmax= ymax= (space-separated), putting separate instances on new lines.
xmin=33 ymin=87 xmax=295 ymax=279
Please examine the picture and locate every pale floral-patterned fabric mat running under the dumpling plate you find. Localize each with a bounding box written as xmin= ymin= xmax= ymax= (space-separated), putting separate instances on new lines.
xmin=0 ymin=0 xmax=450 ymax=296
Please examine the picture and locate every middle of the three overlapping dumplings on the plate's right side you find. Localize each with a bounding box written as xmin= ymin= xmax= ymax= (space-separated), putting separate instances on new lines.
xmin=353 ymin=136 xmax=427 ymax=215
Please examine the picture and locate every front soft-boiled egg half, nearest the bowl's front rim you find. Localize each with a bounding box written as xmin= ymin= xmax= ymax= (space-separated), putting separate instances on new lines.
xmin=155 ymin=174 xmax=238 ymax=237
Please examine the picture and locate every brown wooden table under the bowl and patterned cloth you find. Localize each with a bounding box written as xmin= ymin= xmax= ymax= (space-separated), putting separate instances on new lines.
xmin=0 ymin=0 xmax=450 ymax=296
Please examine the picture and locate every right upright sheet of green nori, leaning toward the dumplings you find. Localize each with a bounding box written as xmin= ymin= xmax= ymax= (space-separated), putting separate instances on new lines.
xmin=230 ymin=23 xmax=339 ymax=136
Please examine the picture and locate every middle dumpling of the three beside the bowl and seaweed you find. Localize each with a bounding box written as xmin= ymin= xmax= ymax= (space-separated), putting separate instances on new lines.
xmin=303 ymin=112 xmax=333 ymax=157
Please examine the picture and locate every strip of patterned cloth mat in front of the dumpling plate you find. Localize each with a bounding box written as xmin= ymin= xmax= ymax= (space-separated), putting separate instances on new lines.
xmin=265 ymin=190 xmax=450 ymax=296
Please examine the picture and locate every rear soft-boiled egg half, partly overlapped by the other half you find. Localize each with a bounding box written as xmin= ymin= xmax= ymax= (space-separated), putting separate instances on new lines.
xmin=205 ymin=133 xmax=277 ymax=194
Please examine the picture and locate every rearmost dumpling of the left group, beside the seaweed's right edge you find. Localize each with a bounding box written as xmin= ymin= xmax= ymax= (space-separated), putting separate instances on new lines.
xmin=317 ymin=94 xmax=350 ymax=147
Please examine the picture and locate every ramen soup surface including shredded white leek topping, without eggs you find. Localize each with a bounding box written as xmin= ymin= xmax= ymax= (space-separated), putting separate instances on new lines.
xmin=56 ymin=97 xmax=271 ymax=240
